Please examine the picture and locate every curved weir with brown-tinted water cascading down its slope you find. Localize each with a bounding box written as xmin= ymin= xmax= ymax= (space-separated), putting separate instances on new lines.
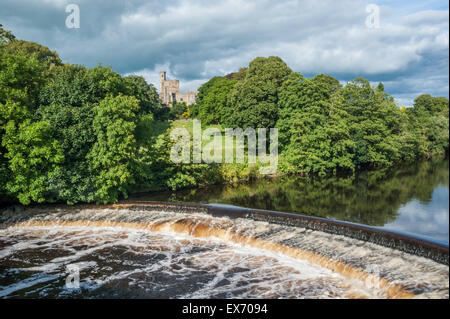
xmin=0 ymin=202 xmax=449 ymax=298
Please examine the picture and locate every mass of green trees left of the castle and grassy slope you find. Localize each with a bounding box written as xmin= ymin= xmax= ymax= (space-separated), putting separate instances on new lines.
xmin=0 ymin=25 xmax=218 ymax=204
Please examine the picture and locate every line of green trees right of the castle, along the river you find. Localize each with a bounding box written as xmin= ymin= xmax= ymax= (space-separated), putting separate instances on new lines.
xmin=191 ymin=57 xmax=449 ymax=176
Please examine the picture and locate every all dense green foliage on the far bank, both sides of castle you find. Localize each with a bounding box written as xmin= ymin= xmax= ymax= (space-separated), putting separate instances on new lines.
xmin=0 ymin=25 xmax=449 ymax=204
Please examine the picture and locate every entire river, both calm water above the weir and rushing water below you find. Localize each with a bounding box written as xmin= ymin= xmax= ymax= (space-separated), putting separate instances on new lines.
xmin=0 ymin=159 xmax=449 ymax=299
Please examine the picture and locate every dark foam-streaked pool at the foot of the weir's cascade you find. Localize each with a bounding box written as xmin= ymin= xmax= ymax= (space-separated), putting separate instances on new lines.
xmin=0 ymin=227 xmax=384 ymax=298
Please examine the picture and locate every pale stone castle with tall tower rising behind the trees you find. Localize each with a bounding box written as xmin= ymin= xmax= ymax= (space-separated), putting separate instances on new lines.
xmin=159 ymin=71 xmax=197 ymax=106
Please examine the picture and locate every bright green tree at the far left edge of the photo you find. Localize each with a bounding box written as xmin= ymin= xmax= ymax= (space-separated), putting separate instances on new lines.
xmin=0 ymin=44 xmax=49 ymax=203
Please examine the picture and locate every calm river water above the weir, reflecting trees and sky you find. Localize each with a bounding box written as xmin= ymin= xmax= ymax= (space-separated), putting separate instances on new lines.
xmin=130 ymin=159 xmax=449 ymax=243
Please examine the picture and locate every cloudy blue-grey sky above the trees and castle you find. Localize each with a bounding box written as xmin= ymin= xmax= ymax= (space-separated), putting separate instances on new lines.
xmin=0 ymin=0 xmax=449 ymax=106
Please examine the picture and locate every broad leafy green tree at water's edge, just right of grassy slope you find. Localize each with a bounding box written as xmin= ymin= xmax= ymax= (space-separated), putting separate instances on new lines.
xmin=277 ymin=73 xmax=354 ymax=176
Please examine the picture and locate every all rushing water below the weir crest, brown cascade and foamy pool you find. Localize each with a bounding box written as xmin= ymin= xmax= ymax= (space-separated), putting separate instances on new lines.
xmin=0 ymin=205 xmax=449 ymax=298
